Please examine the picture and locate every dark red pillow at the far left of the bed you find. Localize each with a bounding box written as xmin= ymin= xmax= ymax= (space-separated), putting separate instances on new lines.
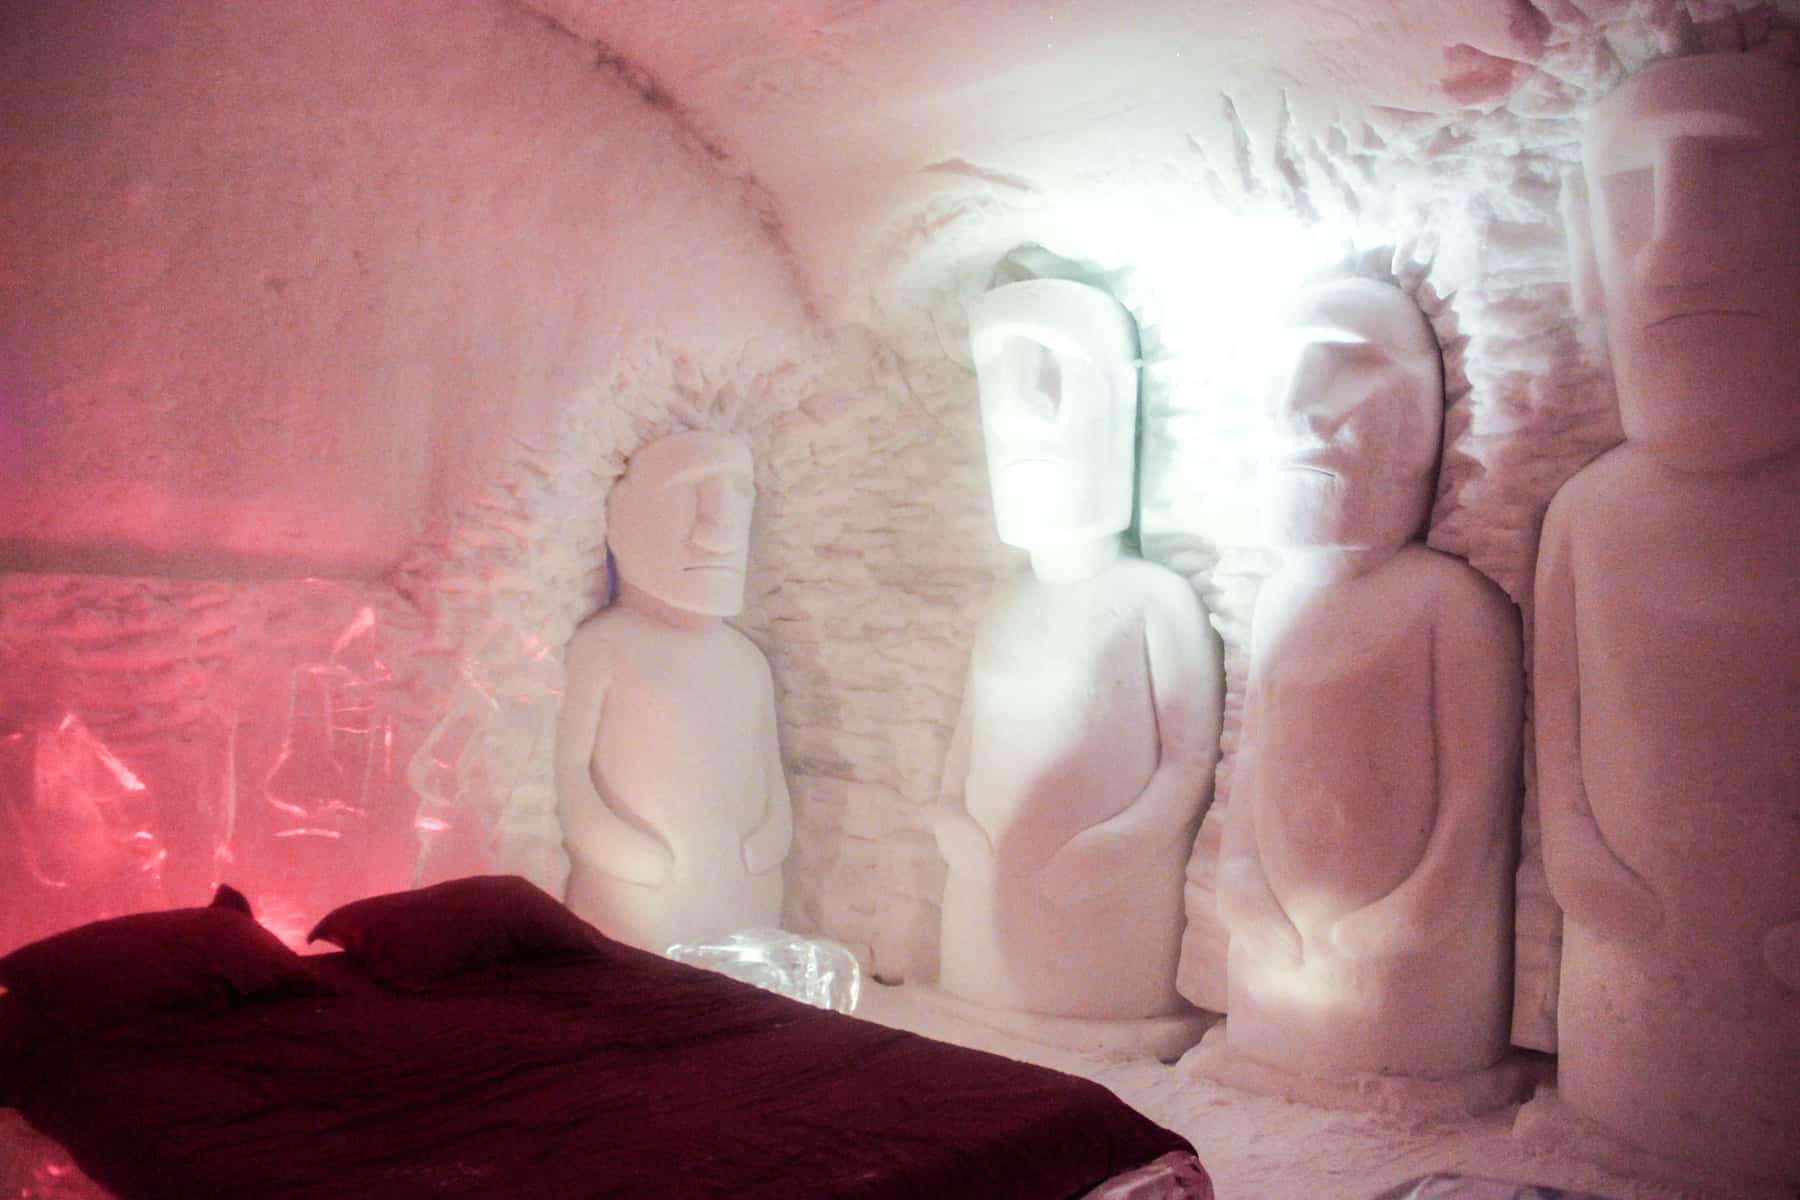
xmin=0 ymin=887 xmax=313 ymax=1025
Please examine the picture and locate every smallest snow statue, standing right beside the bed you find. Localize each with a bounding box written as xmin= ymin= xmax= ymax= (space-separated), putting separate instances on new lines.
xmin=556 ymin=432 xmax=794 ymax=954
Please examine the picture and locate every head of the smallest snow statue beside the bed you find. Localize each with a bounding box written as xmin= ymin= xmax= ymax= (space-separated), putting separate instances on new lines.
xmin=607 ymin=432 xmax=756 ymax=617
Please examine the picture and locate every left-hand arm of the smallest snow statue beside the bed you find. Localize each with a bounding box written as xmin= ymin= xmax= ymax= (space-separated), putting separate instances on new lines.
xmin=556 ymin=622 xmax=675 ymax=885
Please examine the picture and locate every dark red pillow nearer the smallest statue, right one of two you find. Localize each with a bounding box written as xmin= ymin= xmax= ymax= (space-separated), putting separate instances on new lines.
xmin=306 ymin=874 xmax=608 ymax=988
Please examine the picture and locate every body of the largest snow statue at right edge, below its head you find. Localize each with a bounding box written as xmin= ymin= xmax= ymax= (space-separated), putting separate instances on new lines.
xmin=1557 ymin=444 xmax=1800 ymax=1177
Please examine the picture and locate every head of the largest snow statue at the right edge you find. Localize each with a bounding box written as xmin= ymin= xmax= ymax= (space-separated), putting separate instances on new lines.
xmin=1566 ymin=54 xmax=1800 ymax=471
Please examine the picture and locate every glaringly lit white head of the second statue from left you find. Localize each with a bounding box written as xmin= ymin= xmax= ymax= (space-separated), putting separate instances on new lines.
xmin=968 ymin=279 xmax=1138 ymax=551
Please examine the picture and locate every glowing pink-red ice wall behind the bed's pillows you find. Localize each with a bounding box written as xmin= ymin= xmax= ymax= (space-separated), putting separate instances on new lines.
xmin=0 ymin=576 xmax=432 ymax=945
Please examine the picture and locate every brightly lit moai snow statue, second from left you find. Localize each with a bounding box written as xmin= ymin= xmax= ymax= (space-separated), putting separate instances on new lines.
xmin=936 ymin=253 xmax=1220 ymax=1021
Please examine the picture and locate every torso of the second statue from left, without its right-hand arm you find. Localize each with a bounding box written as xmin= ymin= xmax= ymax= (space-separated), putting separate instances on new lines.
xmin=941 ymin=560 xmax=1206 ymax=1018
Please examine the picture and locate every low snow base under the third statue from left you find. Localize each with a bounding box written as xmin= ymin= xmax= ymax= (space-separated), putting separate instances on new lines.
xmin=1179 ymin=1022 xmax=1543 ymax=1123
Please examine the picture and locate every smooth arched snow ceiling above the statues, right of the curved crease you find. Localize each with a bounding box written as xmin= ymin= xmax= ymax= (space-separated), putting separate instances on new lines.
xmin=522 ymin=0 xmax=1562 ymax=315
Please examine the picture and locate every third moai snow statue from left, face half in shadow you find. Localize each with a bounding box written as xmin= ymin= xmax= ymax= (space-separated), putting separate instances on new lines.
xmin=1219 ymin=279 xmax=1523 ymax=1079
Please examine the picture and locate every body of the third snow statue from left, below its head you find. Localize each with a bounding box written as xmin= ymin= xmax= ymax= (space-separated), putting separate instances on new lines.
xmin=1228 ymin=545 xmax=1521 ymax=1078
